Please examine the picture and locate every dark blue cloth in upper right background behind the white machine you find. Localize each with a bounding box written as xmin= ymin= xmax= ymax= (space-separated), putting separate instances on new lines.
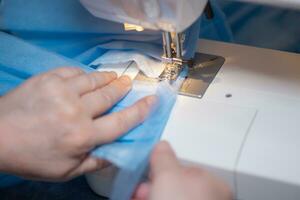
xmin=218 ymin=0 xmax=300 ymax=53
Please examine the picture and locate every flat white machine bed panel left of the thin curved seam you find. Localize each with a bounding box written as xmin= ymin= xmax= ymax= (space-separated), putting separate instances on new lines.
xmin=162 ymin=96 xmax=256 ymax=187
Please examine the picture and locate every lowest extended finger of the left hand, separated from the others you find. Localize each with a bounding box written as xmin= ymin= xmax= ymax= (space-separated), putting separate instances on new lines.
xmin=93 ymin=96 xmax=157 ymax=145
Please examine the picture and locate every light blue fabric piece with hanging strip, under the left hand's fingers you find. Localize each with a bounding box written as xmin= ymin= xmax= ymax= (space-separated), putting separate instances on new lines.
xmin=97 ymin=79 xmax=177 ymax=200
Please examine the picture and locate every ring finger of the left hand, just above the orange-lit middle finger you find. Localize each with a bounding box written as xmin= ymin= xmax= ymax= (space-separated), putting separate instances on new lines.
xmin=67 ymin=72 xmax=117 ymax=95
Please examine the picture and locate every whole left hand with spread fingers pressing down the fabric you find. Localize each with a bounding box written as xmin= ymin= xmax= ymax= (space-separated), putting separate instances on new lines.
xmin=0 ymin=67 xmax=156 ymax=180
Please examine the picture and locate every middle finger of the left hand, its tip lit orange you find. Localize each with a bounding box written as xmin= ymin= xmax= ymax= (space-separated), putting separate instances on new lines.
xmin=82 ymin=76 xmax=132 ymax=117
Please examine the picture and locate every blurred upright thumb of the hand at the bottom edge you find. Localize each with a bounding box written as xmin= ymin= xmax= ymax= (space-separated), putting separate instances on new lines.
xmin=150 ymin=142 xmax=180 ymax=179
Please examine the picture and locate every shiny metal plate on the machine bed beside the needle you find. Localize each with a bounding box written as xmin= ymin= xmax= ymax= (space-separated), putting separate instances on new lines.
xmin=179 ymin=53 xmax=225 ymax=98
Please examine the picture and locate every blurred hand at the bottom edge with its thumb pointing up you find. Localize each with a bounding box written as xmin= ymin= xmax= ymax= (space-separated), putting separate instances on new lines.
xmin=134 ymin=142 xmax=232 ymax=200
